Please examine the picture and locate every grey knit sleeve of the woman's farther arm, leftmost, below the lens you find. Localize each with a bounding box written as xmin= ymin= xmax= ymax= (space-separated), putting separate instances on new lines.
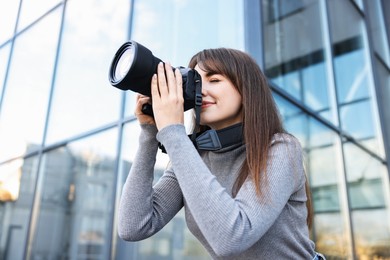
xmin=118 ymin=125 xmax=183 ymax=241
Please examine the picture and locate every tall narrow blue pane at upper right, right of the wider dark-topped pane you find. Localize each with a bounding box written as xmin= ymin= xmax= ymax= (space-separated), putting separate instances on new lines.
xmin=329 ymin=0 xmax=384 ymax=156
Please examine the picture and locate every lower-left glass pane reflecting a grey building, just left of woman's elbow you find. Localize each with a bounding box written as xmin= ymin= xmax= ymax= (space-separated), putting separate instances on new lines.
xmin=31 ymin=129 xmax=117 ymax=260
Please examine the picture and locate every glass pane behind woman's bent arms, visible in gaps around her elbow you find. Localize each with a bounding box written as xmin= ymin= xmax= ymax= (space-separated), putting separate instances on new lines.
xmin=120 ymin=121 xmax=210 ymax=260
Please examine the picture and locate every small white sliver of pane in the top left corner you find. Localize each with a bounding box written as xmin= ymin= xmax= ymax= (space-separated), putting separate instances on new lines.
xmin=0 ymin=0 xmax=20 ymax=46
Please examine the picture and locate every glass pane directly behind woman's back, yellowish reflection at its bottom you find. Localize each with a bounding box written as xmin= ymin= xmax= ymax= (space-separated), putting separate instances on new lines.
xmin=275 ymin=95 xmax=351 ymax=258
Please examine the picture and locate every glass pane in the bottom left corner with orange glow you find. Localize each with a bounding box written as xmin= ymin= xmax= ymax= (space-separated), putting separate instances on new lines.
xmin=0 ymin=157 xmax=38 ymax=259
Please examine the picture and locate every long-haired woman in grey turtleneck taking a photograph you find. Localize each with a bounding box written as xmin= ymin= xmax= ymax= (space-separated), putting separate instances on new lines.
xmin=118 ymin=48 xmax=320 ymax=259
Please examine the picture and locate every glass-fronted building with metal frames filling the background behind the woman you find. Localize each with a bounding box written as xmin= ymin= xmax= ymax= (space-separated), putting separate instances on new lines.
xmin=0 ymin=0 xmax=390 ymax=260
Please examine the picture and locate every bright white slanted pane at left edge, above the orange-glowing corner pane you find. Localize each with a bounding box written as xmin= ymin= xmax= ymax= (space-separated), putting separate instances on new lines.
xmin=0 ymin=8 xmax=61 ymax=161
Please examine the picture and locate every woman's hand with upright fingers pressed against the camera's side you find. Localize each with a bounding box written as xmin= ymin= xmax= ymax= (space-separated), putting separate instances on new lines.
xmin=151 ymin=62 xmax=184 ymax=130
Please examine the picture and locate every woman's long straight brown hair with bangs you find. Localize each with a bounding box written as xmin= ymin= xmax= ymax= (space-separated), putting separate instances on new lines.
xmin=189 ymin=48 xmax=311 ymax=228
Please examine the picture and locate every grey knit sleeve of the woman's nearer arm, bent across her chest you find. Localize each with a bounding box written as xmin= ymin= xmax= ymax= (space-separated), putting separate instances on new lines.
xmin=157 ymin=125 xmax=301 ymax=256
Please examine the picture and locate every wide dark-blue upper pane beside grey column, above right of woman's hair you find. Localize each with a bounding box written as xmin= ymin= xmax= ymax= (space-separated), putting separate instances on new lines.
xmin=262 ymin=0 xmax=337 ymax=124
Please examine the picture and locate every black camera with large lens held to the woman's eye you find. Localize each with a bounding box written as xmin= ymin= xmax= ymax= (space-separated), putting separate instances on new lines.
xmin=109 ymin=41 xmax=202 ymax=116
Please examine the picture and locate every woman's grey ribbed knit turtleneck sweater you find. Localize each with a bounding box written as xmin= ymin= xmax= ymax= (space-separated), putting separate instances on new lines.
xmin=118 ymin=125 xmax=315 ymax=260
